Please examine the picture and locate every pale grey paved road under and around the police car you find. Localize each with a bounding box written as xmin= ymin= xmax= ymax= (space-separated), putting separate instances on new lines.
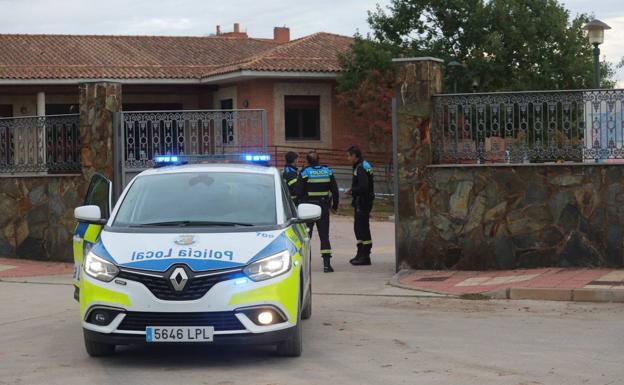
xmin=0 ymin=216 xmax=624 ymax=385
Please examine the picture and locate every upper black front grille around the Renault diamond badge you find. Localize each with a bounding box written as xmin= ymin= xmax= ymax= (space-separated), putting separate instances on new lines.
xmin=117 ymin=270 xmax=245 ymax=301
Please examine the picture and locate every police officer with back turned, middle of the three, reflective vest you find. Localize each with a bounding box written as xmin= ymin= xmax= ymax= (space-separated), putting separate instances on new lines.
xmin=297 ymin=151 xmax=340 ymax=273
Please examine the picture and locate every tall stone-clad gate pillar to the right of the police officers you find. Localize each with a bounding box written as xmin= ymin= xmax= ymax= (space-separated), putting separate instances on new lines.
xmin=393 ymin=57 xmax=443 ymax=269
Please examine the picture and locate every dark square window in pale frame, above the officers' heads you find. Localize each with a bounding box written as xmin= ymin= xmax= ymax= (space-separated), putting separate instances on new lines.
xmin=284 ymin=95 xmax=321 ymax=140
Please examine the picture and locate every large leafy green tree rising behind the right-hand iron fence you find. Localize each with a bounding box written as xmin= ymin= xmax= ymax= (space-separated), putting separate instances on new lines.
xmin=368 ymin=0 xmax=614 ymax=91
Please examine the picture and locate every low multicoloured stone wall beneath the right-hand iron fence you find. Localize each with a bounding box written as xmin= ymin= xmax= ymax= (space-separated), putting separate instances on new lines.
xmin=398 ymin=165 xmax=624 ymax=269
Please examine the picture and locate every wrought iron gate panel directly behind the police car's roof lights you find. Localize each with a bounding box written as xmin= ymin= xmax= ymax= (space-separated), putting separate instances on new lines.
xmin=121 ymin=110 xmax=266 ymax=170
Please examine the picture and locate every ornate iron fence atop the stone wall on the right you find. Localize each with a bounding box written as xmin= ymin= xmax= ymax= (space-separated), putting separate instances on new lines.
xmin=432 ymin=90 xmax=624 ymax=164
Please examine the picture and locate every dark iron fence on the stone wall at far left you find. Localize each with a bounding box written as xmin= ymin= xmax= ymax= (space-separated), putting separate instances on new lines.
xmin=0 ymin=114 xmax=80 ymax=174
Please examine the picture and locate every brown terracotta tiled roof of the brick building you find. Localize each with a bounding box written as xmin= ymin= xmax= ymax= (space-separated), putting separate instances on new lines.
xmin=0 ymin=33 xmax=352 ymax=79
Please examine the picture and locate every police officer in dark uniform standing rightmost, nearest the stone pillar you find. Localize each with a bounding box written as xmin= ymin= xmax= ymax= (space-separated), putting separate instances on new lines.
xmin=347 ymin=146 xmax=375 ymax=266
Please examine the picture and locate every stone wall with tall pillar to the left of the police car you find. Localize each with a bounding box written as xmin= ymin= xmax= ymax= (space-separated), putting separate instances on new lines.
xmin=0 ymin=82 xmax=121 ymax=261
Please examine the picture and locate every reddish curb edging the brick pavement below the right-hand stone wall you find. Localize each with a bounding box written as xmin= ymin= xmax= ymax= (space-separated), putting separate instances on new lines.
xmin=483 ymin=288 xmax=624 ymax=303
